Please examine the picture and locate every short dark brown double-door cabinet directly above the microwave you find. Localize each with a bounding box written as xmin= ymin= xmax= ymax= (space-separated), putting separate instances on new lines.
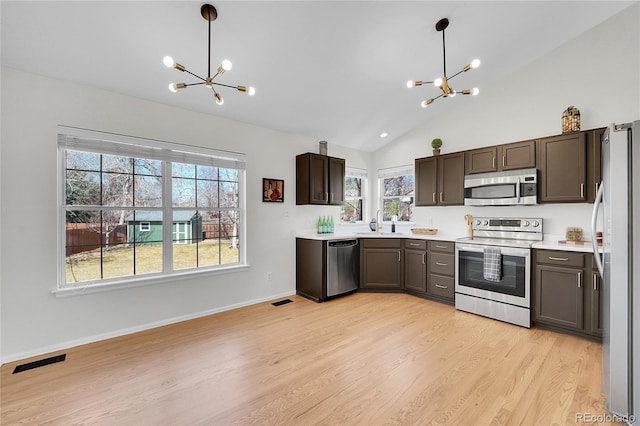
xmin=465 ymin=140 xmax=536 ymax=175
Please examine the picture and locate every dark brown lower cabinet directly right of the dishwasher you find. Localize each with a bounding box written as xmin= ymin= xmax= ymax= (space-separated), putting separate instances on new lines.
xmin=360 ymin=238 xmax=403 ymax=290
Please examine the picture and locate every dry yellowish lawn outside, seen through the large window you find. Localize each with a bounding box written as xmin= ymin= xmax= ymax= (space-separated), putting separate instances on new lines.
xmin=66 ymin=240 xmax=239 ymax=283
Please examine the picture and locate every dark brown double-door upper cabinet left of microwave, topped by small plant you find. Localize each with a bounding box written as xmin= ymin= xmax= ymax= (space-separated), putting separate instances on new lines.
xmin=415 ymin=152 xmax=464 ymax=206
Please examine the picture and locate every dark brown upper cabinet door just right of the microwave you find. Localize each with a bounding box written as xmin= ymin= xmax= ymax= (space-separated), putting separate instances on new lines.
xmin=538 ymin=133 xmax=587 ymax=203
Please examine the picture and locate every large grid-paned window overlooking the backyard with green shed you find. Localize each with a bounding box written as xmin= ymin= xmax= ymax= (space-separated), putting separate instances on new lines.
xmin=58 ymin=126 xmax=246 ymax=289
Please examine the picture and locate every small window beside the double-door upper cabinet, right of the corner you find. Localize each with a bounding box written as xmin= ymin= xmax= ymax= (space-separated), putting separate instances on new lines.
xmin=378 ymin=166 xmax=415 ymax=222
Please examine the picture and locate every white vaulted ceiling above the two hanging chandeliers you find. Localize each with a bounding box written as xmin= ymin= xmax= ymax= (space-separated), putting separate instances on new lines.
xmin=1 ymin=0 xmax=634 ymax=151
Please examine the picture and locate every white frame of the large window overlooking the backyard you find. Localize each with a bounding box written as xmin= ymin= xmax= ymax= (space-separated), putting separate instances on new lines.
xmin=52 ymin=126 xmax=249 ymax=296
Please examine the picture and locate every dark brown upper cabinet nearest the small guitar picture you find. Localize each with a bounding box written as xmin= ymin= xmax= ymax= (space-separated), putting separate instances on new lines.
xmin=296 ymin=153 xmax=345 ymax=205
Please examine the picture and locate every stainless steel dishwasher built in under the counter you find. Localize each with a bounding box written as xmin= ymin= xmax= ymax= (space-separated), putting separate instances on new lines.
xmin=327 ymin=239 xmax=360 ymax=297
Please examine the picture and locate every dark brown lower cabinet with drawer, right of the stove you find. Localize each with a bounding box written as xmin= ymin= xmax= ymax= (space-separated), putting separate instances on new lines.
xmin=533 ymin=250 xmax=602 ymax=338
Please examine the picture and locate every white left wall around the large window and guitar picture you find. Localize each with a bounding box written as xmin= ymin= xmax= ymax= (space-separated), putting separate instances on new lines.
xmin=0 ymin=68 xmax=371 ymax=362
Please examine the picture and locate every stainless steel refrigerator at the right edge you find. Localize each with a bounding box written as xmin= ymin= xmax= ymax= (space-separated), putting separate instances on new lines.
xmin=591 ymin=120 xmax=640 ymax=424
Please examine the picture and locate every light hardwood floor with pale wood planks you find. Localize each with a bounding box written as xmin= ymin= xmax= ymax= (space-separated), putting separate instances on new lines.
xmin=0 ymin=293 xmax=616 ymax=425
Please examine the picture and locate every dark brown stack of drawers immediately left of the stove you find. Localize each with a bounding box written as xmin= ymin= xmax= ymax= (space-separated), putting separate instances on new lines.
xmin=427 ymin=241 xmax=455 ymax=304
